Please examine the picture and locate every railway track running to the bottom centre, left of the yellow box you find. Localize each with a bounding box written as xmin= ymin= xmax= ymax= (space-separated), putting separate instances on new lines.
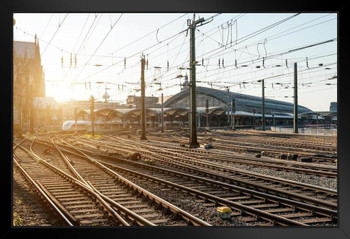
xmin=24 ymin=135 xmax=210 ymax=226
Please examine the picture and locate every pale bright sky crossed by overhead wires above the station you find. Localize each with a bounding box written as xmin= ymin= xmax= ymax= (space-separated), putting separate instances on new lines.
xmin=13 ymin=13 xmax=337 ymax=111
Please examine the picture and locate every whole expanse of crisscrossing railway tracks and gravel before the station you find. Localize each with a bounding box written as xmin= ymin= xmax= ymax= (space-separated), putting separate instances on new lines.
xmin=13 ymin=130 xmax=338 ymax=226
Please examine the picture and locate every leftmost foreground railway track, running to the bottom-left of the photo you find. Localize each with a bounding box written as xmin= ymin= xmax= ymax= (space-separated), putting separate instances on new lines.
xmin=13 ymin=140 xmax=123 ymax=226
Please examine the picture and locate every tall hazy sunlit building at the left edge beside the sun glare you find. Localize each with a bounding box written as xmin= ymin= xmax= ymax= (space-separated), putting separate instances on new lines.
xmin=13 ymin=36 xmax=45 ymax=132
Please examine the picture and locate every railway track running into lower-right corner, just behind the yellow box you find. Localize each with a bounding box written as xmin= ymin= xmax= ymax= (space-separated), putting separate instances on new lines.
xmin=38 ymin=136 xmax=337 ymax=226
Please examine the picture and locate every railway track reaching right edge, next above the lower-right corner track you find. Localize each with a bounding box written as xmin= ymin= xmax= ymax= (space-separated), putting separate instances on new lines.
xmin=64 ymin=135 xmax=337 ymax=209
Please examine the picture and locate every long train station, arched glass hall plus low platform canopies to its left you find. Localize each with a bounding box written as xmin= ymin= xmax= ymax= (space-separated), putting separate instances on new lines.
xmin=70 ymin=87 xmax=312 ymax=129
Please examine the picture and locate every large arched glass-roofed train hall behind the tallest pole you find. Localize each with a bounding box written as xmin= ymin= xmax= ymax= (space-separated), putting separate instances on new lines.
xmin=164 ymin=86 xmax=311 ymax=127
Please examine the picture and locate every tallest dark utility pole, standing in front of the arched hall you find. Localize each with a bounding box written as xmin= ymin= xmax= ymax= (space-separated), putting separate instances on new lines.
xmin=187 ymin=14 xmax=204 ymax=148
